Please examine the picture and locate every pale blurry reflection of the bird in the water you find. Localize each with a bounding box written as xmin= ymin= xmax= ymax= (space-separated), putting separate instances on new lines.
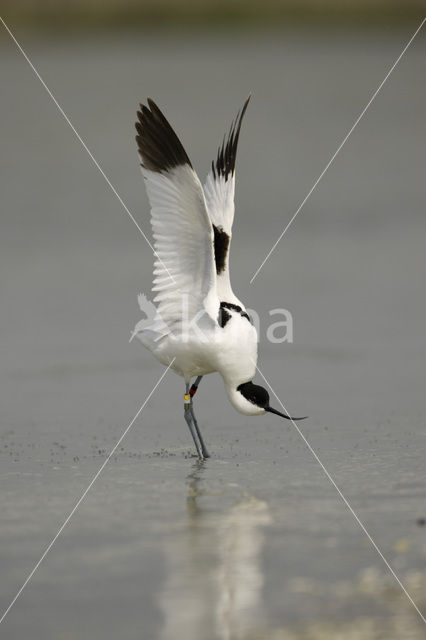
xmin=160 ymin=461 xmax=271 ymax=640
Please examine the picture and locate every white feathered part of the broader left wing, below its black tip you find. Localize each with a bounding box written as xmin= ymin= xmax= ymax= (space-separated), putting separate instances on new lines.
xmin=142 ymin=164 xmax=218 ymax=328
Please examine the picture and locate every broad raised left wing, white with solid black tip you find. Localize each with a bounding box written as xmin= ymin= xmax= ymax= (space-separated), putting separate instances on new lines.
xmin=136 ymin=98 xmax=218 ymax=331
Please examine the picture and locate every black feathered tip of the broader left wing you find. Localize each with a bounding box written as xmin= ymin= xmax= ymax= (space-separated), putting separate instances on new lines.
xmin=135 ymin=98 xmax=192 ymax=173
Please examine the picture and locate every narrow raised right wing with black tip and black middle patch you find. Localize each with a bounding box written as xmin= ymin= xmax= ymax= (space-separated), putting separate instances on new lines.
xmin=204 ymin=96 xmax=250 ymax=307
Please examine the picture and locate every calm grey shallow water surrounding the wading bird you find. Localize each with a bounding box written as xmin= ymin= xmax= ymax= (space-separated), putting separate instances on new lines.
xmin=0 ymin=32 xmax=426 ymax=640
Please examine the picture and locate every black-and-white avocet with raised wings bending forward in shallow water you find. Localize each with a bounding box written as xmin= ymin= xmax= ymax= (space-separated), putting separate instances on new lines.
xmin=133 ymin=95 xmax=306 ymax=460
